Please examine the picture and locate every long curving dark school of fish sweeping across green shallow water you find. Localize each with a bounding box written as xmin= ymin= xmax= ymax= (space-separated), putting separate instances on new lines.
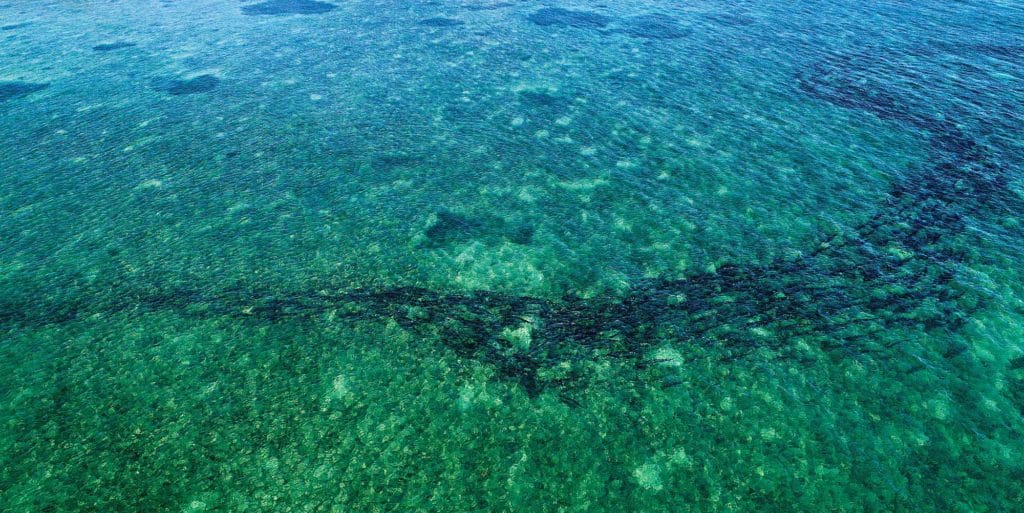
xmin=0 ymin=39 xmax=1024 ymax=403
